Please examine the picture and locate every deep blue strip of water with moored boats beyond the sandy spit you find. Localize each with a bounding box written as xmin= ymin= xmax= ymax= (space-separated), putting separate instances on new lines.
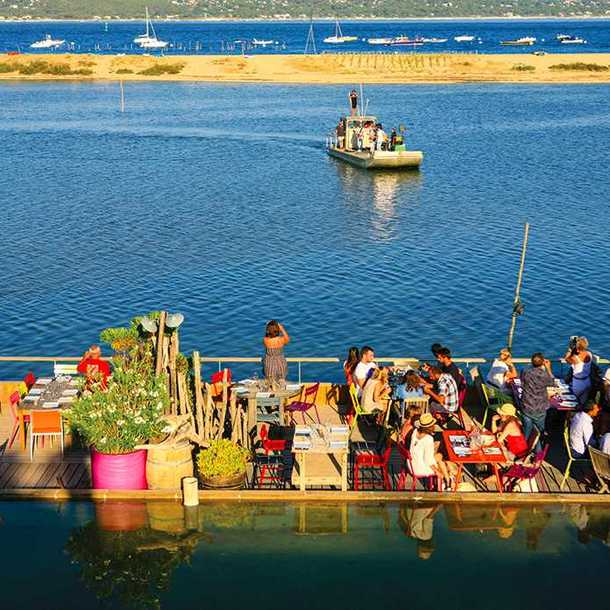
xmin=0 ymin=19 xmax=610 ymax=54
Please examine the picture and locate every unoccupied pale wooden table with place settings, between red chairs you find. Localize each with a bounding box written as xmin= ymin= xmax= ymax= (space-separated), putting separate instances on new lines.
xmin=292 ymin=424 xmax=349 ymax=491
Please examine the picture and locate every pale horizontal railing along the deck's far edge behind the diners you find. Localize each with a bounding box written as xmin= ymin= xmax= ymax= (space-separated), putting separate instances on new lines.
xmin=0 ymin=355 xmax=610 ymax=383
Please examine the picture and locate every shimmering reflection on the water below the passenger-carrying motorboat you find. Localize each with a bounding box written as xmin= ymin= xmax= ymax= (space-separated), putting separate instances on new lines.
xmin=332 ymin=160 xmax=423 ymax=241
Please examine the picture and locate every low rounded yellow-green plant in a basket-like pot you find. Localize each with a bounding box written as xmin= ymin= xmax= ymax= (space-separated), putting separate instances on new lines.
xmin=197 ymin=439 xmax=250 ymax=489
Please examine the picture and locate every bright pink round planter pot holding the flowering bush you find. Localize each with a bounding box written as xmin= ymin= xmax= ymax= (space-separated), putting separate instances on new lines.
xmin=91 ymin=447 xmax=148 ymax=489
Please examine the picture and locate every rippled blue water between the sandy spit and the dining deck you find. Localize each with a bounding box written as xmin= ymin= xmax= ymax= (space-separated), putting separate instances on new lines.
xmin=0 ymin=82 xmax=610 ymax=379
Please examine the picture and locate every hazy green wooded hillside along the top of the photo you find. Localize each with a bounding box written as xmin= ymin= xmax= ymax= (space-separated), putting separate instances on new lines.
xmin=0 ymin=0 xmax=610 ymax=19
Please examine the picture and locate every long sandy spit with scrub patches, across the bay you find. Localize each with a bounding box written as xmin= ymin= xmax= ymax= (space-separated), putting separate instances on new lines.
xmin=0 ymin=53 xmax=610 ymax=84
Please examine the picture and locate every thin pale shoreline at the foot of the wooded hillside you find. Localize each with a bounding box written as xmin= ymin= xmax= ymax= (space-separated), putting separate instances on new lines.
xmin=0 ymin=15 xmax=610 ymax=25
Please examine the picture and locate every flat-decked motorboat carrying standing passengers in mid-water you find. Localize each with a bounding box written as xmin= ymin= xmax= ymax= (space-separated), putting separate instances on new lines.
xmin=326 ymin=115 xmax=424 ymax=169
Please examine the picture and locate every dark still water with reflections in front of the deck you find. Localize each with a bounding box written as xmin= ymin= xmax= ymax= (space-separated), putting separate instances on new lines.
xmin=0 ymin=502 xmax=610 ymax=610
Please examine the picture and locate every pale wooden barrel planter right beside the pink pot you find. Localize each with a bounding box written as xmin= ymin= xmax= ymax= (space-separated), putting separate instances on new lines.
xmin=146 ymin=440 xmax=193 ymax=489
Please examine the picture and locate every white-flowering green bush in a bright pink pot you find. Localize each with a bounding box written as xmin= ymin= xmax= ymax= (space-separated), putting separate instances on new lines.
xmin=66 ymin=359 xmax=169 ymax=489
